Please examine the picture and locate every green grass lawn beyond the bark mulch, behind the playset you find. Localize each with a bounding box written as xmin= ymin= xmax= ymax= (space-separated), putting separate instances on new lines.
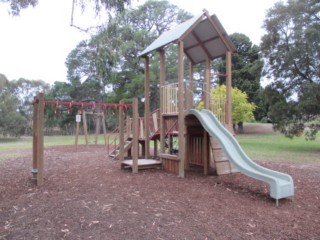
xmin=0 ymin=133 xmax=320 ymax=163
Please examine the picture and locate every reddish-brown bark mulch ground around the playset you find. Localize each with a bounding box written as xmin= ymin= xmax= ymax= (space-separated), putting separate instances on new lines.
xmin=0 ymin=130 xmax=320 ymax=240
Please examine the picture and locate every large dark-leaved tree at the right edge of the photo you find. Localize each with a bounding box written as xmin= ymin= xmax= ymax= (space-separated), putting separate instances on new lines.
xmin=261 ymin=0 xmax=320 ymax=139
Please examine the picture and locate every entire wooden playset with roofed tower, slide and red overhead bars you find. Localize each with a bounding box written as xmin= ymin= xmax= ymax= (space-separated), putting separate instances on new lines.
xmin=32 ymin=8 xmax=294 ymax=206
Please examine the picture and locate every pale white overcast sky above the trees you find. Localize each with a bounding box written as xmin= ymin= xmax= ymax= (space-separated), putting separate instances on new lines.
xmin=0 ymin=0 xmax=278 ymax=84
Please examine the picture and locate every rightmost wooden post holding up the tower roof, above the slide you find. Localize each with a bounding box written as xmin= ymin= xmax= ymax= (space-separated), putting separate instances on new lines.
xmin=225 ymin=52 xmax=233 ymax=133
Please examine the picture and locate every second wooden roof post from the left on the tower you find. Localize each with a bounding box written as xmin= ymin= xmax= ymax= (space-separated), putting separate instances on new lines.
xmin=159 ymin=49 xmax=166 ymax=157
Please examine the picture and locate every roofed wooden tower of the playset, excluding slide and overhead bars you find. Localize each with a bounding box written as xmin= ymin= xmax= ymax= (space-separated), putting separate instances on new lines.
xmin=133 ymin=10 xmax=236 ymax=177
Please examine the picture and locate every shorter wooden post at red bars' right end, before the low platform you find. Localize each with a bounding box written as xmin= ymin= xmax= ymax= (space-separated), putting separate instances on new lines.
xmin=132 ymin=98 xmax=139 ymax=173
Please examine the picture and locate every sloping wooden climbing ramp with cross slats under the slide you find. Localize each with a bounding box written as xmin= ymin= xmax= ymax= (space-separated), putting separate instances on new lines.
xmin=210 ymin=137 xmax=239 ymax=175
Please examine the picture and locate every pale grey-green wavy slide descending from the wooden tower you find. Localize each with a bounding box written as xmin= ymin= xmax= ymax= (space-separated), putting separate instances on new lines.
xmin=189 ymin=109 xmax=294 ymax=200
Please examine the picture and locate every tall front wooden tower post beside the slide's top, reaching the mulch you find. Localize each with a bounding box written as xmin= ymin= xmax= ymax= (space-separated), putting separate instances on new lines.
xmin=178 ymin=41 xmax=185 ymax=178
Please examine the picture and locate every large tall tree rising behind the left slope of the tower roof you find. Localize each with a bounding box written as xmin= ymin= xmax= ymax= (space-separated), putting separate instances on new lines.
xmin=66 ymin=1 xmax=191 ymax=108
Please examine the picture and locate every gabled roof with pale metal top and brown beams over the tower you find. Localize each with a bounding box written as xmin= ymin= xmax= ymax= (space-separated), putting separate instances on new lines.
xmin=139 ymin=10 xmax=236 ymax=64
